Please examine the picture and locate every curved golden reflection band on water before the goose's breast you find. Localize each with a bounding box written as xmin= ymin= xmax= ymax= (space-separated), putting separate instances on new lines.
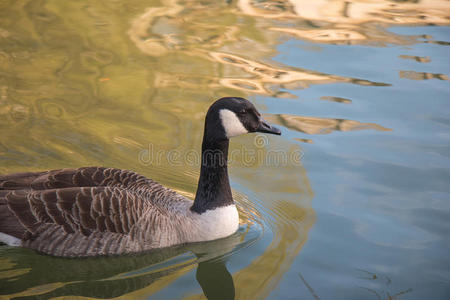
xmin=187 ymin=140 xmax=316 ymax=299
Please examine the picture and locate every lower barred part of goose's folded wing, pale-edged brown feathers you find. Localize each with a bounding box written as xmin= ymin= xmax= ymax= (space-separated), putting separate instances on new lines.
xmin=5 ymin=187 xmax=148 ymax=236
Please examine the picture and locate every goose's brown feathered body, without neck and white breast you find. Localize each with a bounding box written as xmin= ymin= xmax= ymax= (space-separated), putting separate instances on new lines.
xmin=0 ymin=167 xmax=237 ymax=257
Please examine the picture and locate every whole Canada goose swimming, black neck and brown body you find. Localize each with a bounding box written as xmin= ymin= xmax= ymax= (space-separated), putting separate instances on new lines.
xmin=0 ymin=97 xmax=281 ymax=257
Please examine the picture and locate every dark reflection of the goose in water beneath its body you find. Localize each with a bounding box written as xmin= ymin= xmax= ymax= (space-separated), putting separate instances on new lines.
xmin=0 ymin=230 xmax=248 ymax=299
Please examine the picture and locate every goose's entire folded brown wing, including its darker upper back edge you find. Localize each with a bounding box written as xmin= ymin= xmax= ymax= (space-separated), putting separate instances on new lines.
xmin=0 ymin=167 xmax=153 ymax=238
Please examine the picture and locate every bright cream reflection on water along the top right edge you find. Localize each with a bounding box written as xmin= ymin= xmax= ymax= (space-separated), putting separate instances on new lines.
xmin=243 ymin=0 xmax=449 ymax=44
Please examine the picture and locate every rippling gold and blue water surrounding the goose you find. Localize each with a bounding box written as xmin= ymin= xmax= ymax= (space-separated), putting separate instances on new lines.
xmin=0 ymin=0 xmax=450 ymax=299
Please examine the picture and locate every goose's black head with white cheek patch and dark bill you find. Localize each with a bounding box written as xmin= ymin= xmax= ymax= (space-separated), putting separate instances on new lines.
xmin=204 ymin=97 xmax=281 ymax=141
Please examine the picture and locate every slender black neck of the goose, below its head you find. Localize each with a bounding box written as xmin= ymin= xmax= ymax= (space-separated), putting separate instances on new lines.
xmin=191 ymin=137 xmax=234 ymax=214
